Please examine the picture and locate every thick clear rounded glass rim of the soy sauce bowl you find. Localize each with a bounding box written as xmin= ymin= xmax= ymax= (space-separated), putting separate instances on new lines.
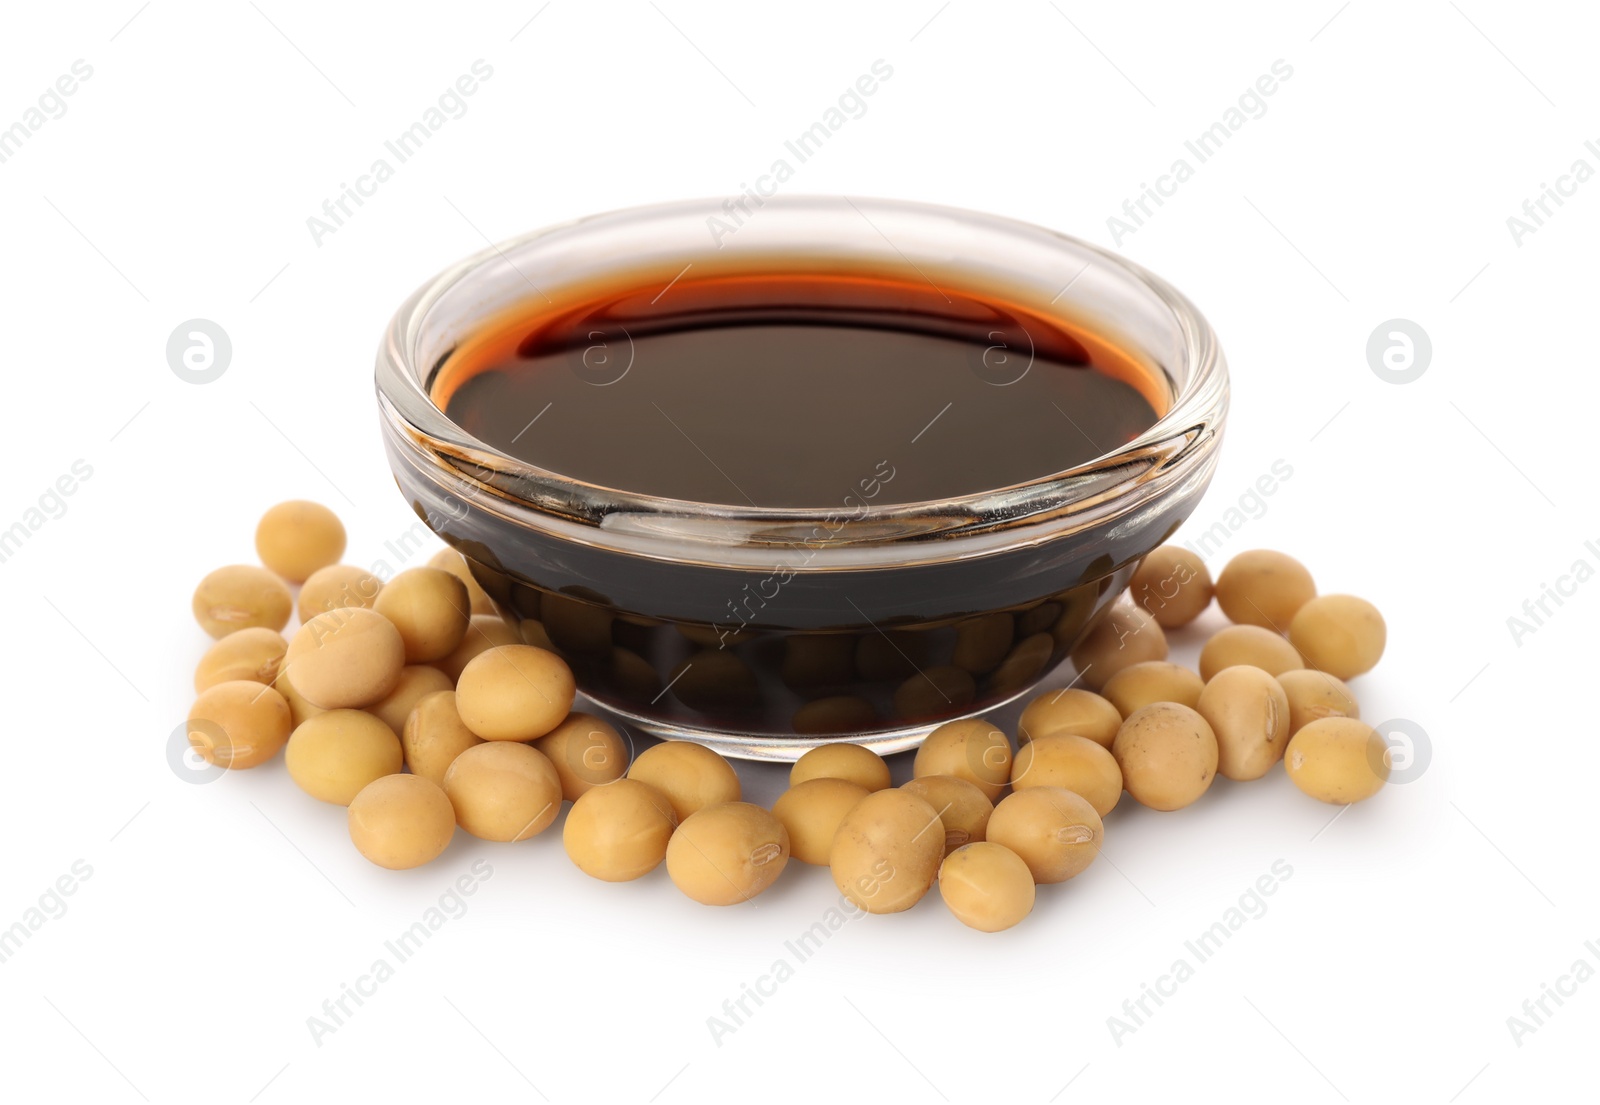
xmin=374 ymin=193 xmax=1229 ymax=571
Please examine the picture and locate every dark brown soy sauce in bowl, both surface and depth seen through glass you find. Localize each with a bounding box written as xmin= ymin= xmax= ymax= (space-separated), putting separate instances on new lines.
xmin=406 ymin=270 xmax=1202 ymax=736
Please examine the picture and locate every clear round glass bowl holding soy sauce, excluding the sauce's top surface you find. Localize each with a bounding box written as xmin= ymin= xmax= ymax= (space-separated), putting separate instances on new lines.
xmin=376 ymin=197 xmax=1227 ymax=761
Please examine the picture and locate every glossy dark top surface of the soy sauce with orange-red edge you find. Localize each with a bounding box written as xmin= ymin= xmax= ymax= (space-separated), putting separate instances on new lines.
xmin=434 ymin=277 xmax=1162 ymax=507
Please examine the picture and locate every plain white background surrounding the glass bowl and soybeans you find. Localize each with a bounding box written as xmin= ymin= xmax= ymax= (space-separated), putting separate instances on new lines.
xmin=0 ymin=0 xmax=1600 ymax=1103
